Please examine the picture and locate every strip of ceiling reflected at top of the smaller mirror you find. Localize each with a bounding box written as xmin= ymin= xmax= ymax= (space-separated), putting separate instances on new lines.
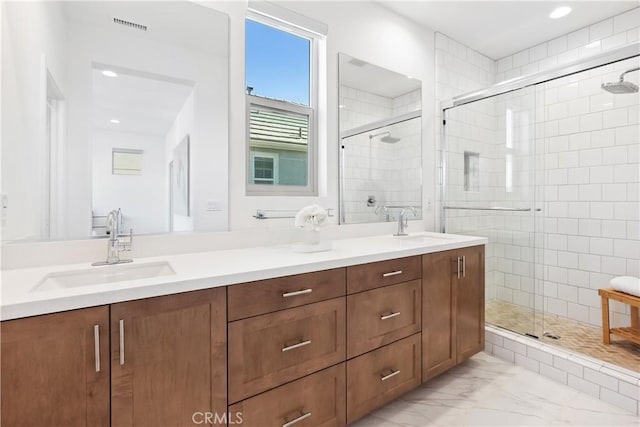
xmin=339 ymin=53 xmax=421 ymax=98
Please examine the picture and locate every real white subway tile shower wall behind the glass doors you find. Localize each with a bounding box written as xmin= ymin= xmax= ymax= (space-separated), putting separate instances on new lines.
xmin=436 ymin=8 xmax=640 ymax=334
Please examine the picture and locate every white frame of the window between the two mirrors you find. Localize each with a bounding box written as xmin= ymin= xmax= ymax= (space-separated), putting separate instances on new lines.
xmin=244 ymin=14 xmax=320 ymax=196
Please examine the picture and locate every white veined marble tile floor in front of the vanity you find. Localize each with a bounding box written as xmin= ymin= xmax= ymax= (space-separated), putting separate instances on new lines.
xmin=352 ymin=352 xmax=640 ymax=427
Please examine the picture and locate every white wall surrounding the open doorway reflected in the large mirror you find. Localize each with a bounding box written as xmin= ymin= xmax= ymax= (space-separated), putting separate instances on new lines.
xmin=67 ymin=17 xmax=229 ymax=238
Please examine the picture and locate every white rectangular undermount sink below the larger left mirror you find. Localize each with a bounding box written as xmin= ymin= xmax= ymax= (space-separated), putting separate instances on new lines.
xmin=32 ymin=261 xmax=176 ymax=291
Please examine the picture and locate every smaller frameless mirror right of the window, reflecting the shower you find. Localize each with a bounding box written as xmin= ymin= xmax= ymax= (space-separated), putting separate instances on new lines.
xmin=339 ymin=53 xmax=422 ymax=224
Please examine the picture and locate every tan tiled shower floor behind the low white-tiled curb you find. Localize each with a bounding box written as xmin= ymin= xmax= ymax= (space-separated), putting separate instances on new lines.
xmin=485 ymin=300 xmax=640 ymax=372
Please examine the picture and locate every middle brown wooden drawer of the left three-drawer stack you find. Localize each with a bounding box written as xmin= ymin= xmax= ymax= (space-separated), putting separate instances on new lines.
xmin=228 ymin=298 xmax=346 ymax=403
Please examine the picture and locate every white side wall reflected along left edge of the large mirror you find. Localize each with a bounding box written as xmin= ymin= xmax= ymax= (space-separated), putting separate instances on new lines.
xmin=1 ymin=2 xmax=68 ymax=240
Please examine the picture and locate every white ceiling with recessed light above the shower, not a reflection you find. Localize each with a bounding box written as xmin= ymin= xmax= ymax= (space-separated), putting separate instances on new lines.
xmin=380 ymin=0 xmax=640 ymax=59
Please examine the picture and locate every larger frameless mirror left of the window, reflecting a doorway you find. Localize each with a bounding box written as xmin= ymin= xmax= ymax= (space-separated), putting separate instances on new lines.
xmin=1 ymin=1 xmax=229 ymax=241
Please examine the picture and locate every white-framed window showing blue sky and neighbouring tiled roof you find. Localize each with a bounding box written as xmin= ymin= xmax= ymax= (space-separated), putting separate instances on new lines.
xmin=245 ymin=16 xmax=317 ymax=195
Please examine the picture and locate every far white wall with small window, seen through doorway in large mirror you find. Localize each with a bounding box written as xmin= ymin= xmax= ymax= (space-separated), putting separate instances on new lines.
xmin=91 ymin=130 xmax=169 ymax=234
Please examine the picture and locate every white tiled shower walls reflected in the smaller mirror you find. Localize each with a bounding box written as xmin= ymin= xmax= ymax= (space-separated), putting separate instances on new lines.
xmin=340 ymin=85 xmax=422 ymax=223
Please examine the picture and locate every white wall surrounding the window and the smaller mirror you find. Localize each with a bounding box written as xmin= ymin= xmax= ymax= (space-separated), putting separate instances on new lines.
xmin=219 ymin=1 xmax=434 ymax=230
